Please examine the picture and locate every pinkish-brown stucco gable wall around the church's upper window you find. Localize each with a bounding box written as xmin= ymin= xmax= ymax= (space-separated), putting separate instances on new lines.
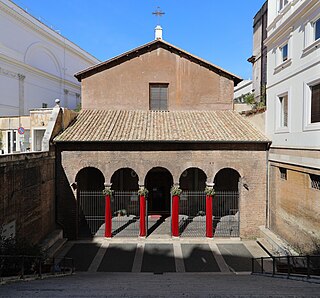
xmin=82 ymin=48 xmax=233 ymax=110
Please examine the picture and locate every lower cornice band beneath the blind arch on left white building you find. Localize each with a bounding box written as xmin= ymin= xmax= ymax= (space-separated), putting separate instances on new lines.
xmin=0 ymin=53 xmax=80 ymax=89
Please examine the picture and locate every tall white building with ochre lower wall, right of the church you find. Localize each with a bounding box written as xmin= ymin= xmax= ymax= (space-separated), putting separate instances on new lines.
xmin=265 ymin=0 xmax=320 ymax=249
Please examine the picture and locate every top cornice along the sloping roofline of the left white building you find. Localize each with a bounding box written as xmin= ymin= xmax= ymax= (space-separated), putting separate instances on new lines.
xmin=0 ymin=1 xmax=100 ymax=64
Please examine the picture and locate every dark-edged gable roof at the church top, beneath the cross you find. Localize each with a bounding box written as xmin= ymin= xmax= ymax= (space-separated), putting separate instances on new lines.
xmin=74 ymin=39 xmax=242 ymax=85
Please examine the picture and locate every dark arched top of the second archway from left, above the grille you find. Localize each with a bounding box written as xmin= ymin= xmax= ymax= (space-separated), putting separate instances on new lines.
xmin=111 ymin=168 xmax=139 ymax=191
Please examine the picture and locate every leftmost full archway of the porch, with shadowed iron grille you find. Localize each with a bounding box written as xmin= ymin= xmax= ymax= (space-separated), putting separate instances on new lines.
xmin=76 ymin=167 xmax=105 ymax=237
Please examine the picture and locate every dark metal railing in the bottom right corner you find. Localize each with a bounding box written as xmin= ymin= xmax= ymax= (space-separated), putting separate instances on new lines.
xmin=251 ymin=255 xmax=320 ymax=278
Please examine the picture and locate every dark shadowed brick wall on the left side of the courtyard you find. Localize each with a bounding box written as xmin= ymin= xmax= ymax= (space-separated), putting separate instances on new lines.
xmin=0 ymin=152 xmax=55 ymax=243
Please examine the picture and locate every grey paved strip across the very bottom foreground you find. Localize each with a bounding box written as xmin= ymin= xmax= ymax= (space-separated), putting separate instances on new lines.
xmin=0 ymin=272 xmax=320 ymax=298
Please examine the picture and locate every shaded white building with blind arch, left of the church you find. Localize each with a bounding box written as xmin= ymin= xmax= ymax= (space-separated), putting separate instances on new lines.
xmin=0 ymin=0 xmax=99 ymax=116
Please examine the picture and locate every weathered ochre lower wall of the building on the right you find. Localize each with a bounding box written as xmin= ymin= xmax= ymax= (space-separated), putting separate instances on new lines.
xmin=270 ymin=159 xmax=320 ymax=252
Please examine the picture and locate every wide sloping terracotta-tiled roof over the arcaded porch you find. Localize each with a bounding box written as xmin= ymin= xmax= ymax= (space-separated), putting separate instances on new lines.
xmin=55 ymin=110 xmax=269 ymax=143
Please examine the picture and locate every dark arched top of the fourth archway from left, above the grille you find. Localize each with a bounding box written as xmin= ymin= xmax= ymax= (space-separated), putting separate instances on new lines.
xmin=179 ymin=168 xmax=207 ymax=191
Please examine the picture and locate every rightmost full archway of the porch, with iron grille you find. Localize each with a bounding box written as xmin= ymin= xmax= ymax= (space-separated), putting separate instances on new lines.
xmin=212 ymin=168 xmax=240 ymax=237
